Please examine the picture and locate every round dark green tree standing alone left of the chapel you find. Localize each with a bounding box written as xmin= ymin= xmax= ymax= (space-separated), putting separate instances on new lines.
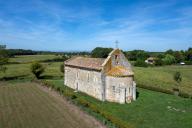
xmin=31 ymin=62 xmax=45 ymax=79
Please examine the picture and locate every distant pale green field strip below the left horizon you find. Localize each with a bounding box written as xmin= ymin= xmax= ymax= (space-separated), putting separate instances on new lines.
xmin=9 ymin=55 xmax=57 ymax=63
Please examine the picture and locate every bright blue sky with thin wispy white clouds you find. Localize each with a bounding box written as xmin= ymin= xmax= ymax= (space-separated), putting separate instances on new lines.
xmin=0 ymin=0 xmax=192 ymax=51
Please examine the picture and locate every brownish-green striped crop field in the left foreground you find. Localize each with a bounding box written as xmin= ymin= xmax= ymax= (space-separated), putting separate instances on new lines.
xmin=0 ymin=82 xmax=105 ymax=128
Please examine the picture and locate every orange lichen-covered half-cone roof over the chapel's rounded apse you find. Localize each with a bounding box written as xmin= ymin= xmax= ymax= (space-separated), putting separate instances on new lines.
xmin=107 ymin=66 xmax=134 ymax=77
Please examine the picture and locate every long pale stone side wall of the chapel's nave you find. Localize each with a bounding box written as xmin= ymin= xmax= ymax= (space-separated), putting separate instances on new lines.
xmin=65 ymin=66 xmax=104 ymax=100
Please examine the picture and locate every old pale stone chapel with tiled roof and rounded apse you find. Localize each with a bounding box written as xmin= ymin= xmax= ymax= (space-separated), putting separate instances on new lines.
xmin=64 ymin=49 xmax=136 ymax=103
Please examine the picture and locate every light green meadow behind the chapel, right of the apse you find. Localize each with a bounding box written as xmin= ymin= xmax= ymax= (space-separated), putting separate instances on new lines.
xmin=134 ymin=65 xmax=192 ymax=95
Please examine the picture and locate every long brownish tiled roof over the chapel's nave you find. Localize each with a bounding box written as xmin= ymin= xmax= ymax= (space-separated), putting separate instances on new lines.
xmin=65 ymin=57 xmax=105 ymax=70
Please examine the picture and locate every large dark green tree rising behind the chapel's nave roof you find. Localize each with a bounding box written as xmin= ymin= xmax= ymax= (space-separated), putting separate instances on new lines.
xmin=91 ymin=47 xmax=113 ymax=58
